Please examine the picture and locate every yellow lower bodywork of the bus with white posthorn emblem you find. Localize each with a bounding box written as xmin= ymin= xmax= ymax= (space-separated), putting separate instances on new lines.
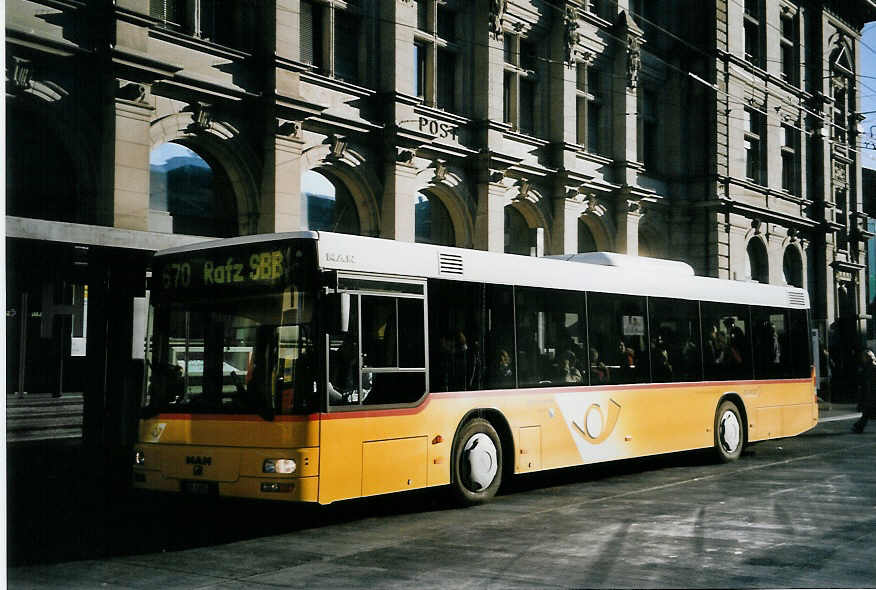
xmin=135 ymin=379 xmax=818 ymax=504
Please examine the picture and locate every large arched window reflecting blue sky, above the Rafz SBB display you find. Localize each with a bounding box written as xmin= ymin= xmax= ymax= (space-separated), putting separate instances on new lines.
xmin=149 ymin=142 xmax=239 ymax=237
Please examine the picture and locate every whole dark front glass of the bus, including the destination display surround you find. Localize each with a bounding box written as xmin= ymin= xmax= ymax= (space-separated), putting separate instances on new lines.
xmin=144 ymin=239 xmax=318 ymax=419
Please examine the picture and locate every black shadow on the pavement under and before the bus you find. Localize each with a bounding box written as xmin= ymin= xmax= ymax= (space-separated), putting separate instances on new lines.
xmin=7 ymin=423 xmax=866 ymax=566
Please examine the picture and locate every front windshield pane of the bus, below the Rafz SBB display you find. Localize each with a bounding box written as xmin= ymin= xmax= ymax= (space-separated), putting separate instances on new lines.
xmin=147 ymin=294 xmax=313 ymax=413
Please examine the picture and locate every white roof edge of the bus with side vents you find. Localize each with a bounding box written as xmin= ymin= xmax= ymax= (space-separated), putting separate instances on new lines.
xmin=157 ymin=231 xmax=809 ymax=309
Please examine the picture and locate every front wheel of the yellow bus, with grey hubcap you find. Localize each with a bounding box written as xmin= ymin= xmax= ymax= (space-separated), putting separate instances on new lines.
xmin=450 ymin=418 xmax=503 ymax=506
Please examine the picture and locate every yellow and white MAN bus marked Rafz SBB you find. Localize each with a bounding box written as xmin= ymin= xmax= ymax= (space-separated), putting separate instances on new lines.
xmin=133 ymin=232 xmax=818 ymax=504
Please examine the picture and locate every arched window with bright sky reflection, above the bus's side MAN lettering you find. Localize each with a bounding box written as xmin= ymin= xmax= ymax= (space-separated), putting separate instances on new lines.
xmin=301 ymin=170 xmax=360 ymax=235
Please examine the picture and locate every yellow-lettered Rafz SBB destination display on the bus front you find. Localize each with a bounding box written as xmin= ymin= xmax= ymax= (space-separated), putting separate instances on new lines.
xmin=154 ymin=242 xmax=315 ymax=292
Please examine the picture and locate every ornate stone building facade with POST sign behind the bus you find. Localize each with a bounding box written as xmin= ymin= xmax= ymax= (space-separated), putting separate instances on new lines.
xmin=6 ymin=0 xmax=876 ymax=434
